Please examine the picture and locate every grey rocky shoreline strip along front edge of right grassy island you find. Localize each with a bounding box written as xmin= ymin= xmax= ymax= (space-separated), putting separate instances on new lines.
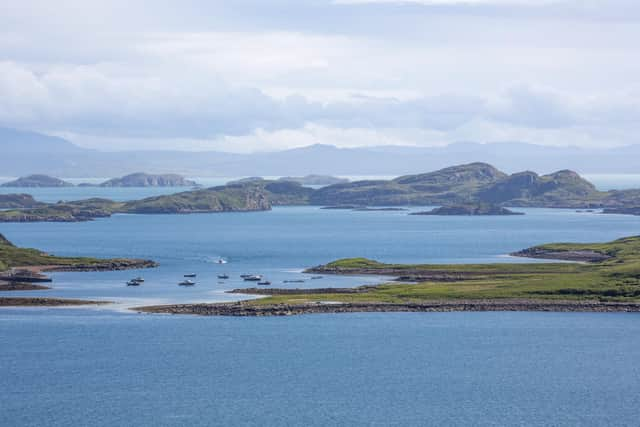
xmin=132 ymin=299 xmax=640 ymax=317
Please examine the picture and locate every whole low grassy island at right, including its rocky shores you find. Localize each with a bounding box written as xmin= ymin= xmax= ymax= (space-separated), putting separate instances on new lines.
xmin=136 ymin=236 xmax=640 ymax=316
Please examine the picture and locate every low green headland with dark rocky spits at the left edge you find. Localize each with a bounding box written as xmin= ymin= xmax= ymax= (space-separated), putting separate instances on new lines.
xmin=0 ymin=234 xmax=158 ymax=306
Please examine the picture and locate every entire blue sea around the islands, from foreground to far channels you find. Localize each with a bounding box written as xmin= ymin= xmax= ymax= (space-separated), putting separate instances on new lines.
xmin=0 ymin=182 xmax=640 ymax=426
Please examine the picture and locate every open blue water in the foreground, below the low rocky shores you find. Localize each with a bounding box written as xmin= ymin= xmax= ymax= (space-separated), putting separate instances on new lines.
xmin=0 ymin=310 xmax=640 ymax=426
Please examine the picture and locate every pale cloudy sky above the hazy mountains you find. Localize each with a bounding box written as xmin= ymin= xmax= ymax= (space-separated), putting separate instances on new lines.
xmin=0 ymin=0 xmax=640 ymax=152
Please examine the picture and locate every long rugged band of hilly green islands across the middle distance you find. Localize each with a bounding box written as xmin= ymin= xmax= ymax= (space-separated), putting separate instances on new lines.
xmin=0 ymin=163 xmax=640 ymax=222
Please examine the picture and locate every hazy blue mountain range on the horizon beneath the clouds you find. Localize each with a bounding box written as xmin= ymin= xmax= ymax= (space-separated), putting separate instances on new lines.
xmin=5 ymin=128 xmax=640 ymax=178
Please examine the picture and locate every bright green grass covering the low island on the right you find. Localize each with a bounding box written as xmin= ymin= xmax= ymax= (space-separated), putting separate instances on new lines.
xmin=247 ymin=236 xmax=640 ymax=305
